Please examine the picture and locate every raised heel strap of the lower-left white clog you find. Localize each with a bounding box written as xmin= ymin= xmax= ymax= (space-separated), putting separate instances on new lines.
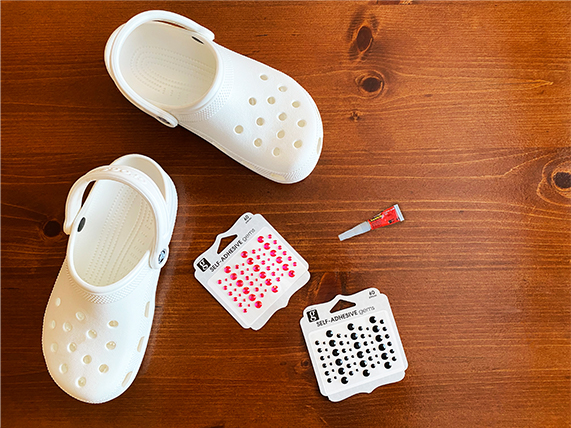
xmin=63 ymin=165 xmax=170 ymax=269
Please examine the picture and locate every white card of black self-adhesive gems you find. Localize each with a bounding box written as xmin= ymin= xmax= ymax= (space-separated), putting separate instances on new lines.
xmin=300 ymin=288 xmax=408 ymax=401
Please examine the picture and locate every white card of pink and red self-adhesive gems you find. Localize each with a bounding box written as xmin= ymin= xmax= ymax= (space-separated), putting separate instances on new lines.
xmin=194 ymin=213 xmax=310 ymax=330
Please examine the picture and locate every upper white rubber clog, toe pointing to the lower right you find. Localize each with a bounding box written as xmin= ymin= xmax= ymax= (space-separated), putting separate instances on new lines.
xmin=105 ymin=10 xmax=323 ymax=183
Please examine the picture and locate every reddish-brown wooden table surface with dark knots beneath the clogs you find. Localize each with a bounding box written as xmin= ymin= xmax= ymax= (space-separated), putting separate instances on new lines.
xmin=1 ymin=1 xmax=571 ymax=427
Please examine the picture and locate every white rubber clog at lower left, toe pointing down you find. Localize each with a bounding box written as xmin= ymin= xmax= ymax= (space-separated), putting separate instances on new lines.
xmin=42 ymin=155 xmax=177 ymax=403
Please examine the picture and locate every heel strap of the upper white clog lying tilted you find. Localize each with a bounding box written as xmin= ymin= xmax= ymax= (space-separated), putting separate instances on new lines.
xmin=105 ymin=10 xmax=220 ymax=128
